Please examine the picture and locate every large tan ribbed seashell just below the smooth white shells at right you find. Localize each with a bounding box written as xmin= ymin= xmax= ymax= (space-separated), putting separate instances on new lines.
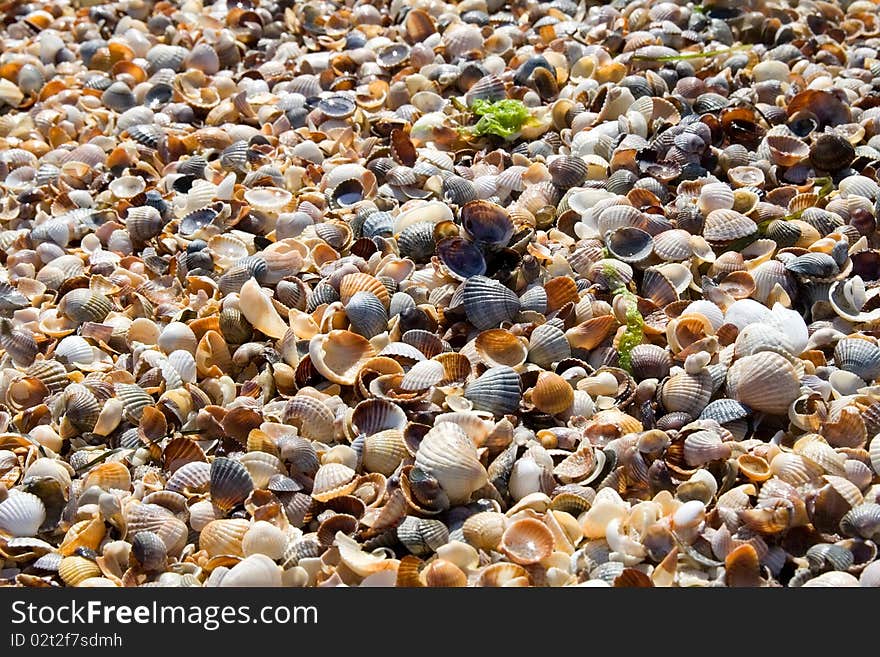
xmin=727 ymin=351 xmax=800 ymax=415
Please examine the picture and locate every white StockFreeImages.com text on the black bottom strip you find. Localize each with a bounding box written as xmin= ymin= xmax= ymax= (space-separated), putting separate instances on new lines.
xmin=12 ymin=600 xmax=318 ymax=632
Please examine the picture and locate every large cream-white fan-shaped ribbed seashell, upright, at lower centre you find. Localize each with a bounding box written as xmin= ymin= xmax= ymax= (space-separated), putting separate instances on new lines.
xmin=415 ymin=422 xmax=488 ymax=504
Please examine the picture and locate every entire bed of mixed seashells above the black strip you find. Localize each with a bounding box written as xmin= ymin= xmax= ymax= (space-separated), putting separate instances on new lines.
xmin=0 ymin=0 xmax=880 ymax=587
